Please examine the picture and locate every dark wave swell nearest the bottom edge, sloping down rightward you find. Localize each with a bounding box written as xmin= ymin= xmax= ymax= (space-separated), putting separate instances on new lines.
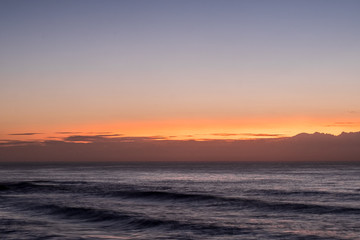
xmin=7 ymin=201 xmax=352 ymax=240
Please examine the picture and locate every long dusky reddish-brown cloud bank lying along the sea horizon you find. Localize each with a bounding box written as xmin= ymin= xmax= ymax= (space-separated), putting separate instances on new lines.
xmin=0 ymin=132 xmax=360 ymax=162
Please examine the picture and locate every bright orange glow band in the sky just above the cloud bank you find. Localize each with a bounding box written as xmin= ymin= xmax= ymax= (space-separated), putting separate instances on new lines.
xmin=1 ymin=117 xmax=360 ymax=141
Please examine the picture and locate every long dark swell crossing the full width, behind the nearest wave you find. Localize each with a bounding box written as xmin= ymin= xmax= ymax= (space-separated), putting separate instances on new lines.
xmin=0 ymin=181 xmax=360 ymax=214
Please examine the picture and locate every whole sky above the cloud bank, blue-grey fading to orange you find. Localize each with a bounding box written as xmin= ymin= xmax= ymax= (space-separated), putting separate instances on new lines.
xmin=0 ymin=0 xmax=360 ymax=142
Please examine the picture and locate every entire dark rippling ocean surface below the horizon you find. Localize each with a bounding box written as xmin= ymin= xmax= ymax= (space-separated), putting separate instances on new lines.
xmin=0 ymin=163 xmax=360 ymax=240
